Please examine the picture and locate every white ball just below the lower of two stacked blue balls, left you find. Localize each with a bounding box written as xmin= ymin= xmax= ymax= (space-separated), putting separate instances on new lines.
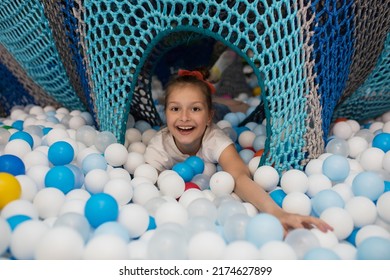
xmin=33 ymin=188 xmax=65 ymax=219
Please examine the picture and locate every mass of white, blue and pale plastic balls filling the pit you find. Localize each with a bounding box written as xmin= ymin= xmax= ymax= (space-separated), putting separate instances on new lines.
xmin=0 ymin=106 xmax=390 ymax=260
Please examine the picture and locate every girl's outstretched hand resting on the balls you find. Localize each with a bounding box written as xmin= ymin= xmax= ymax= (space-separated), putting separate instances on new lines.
xmin=277 ymin=211 xmax=333 ymax=234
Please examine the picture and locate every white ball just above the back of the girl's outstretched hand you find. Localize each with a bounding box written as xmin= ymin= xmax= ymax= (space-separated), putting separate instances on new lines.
xmin=282 ymin=192 xmax=311 ymax=216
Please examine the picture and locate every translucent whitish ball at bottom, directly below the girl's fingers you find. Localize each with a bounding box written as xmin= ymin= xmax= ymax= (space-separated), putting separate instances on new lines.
xmin=284 ymin=228 xmax=320 ymax=259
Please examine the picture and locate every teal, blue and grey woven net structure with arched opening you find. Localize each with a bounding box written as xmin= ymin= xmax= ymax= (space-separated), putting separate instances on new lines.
xmin=0 ymin=0 xmax=390 ymax=171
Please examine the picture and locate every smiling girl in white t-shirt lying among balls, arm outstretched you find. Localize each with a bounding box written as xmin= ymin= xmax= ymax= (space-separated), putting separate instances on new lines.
xmin=145 ymin=70 xmax=332 ymax=232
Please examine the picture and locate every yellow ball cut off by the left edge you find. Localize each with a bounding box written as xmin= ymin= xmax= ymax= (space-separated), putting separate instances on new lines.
xmin=0 ymin=172 xmax=22 ymax=209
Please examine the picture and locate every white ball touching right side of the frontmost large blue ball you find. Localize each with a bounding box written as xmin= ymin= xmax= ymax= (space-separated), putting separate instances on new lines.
xmin=118 ymin=203 xmax=149 ymax=238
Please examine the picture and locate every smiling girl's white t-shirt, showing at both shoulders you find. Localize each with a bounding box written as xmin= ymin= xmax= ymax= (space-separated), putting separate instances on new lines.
xmin=144 ymin=124 xmax=233 ymax=171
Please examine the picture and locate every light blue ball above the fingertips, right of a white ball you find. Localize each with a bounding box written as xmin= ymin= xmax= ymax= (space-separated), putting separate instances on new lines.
xmin=311 ymin=189 xmax=345 ymax=216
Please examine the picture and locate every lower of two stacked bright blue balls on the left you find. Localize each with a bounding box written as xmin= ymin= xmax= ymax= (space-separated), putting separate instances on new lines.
xmin=45 ymin=165 xmax=75 ymax=194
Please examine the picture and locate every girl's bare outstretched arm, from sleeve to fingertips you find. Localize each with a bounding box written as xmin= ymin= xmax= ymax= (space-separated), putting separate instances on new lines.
xmin=219 ymin=144 xmax=332 ymax=232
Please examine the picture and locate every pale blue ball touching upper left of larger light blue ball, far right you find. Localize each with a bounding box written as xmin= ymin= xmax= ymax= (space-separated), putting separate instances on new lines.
xmin=322 ymin=155 xmax=350 ymax=182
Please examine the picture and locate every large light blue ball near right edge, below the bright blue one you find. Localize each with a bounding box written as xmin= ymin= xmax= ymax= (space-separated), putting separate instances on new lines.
xmin=352 ymin=171 xmax=385 ymax=201
